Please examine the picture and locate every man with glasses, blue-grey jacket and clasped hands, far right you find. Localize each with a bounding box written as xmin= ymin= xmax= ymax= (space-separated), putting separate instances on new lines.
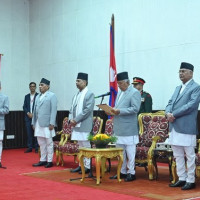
xmin=165 ymin=62 xmax=200 ymax=190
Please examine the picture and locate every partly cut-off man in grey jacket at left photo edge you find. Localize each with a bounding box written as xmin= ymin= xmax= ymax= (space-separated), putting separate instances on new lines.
xmin=0 ymin=82 xmax=9 ymax=167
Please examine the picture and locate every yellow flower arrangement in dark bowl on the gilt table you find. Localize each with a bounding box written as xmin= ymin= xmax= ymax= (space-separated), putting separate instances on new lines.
xmin=88 ymin=133 xmax=117 ymax=148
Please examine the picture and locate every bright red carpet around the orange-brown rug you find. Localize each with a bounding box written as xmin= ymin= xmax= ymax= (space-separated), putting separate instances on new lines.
xmin=0 ymin=149 xmax=145 ymax=200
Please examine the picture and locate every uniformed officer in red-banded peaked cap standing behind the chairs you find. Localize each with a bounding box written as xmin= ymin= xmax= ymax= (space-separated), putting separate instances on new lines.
xmin=132 ymin=77 xmax=152 ymax=115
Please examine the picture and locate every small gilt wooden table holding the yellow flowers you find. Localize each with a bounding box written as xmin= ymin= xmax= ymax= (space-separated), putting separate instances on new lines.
xmin=78 ymin=148 xmax=123 ymax=185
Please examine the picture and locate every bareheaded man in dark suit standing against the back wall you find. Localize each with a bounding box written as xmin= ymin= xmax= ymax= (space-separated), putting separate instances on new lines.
xmin=23 ymin=82 xmax=38 ymax=153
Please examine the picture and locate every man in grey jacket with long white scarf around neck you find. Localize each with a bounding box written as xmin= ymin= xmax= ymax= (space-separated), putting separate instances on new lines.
xmin=69 ymin=72 xmax=95 ymax=173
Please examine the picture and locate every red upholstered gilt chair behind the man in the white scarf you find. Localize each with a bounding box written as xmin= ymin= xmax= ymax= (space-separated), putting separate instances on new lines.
xmin=59 ymin=117 xmax=103 ymax=166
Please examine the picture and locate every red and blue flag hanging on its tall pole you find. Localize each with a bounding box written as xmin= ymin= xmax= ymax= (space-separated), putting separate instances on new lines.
xmin=109 ymin=15 xmax=118 ymax=107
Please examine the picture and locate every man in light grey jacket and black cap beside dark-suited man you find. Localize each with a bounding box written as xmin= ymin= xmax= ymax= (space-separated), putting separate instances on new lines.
xmin=32 ymin=78 xmax=57 ymax=168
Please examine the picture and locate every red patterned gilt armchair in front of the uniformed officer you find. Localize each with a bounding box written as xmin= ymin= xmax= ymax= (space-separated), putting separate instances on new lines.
xmin=135 ymin=113 xmax=168 ymax=180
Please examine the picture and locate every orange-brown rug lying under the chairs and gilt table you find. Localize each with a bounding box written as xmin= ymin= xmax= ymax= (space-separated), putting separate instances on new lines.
xmin=24 ymin=166 xmax=200 ymax=200
